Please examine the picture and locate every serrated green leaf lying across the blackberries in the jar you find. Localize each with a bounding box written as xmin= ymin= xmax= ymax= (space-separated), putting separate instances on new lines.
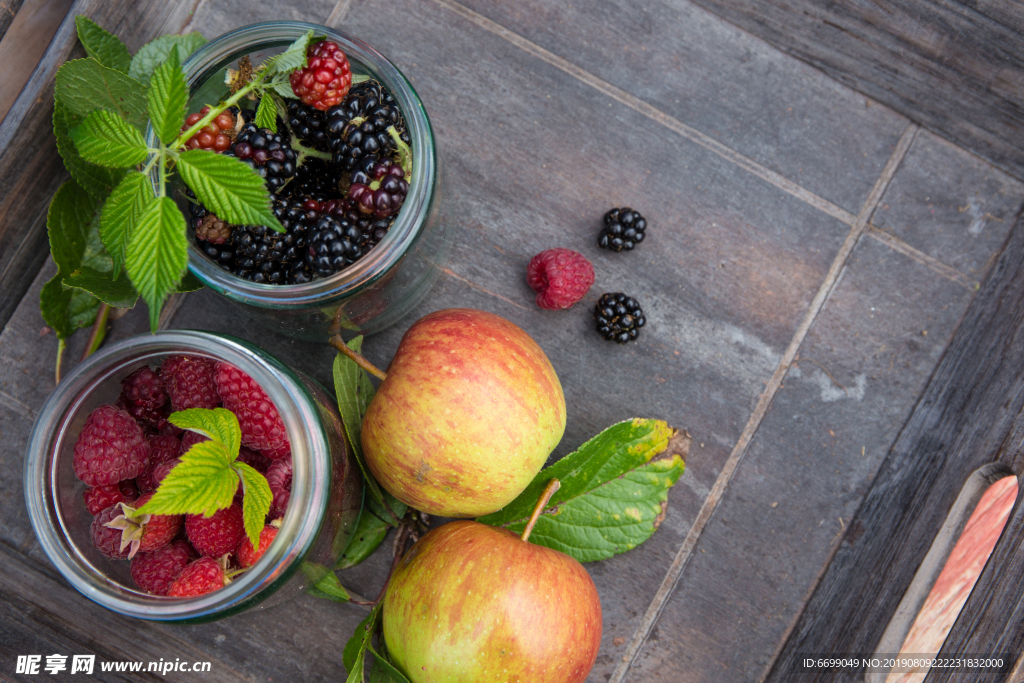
xmin=178 ymin=150 xmax=285 ymax=232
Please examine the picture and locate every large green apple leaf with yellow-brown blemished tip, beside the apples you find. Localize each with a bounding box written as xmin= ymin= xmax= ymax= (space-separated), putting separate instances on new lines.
xmin=477 ymin=418 xmax=689 ymax=562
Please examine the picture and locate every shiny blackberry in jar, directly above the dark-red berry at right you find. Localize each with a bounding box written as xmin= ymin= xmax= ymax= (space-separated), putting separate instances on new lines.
xmin=327 ymin=81 xmax=410 ymax=169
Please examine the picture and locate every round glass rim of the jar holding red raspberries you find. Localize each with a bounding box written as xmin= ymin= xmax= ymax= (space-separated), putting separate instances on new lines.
xmin=24 ymin=330 xmax=332 ymax=621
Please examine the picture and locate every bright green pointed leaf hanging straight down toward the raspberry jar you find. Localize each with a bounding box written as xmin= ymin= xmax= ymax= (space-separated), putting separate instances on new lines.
xmin=125 ymin=194 xmax=187 ymax=330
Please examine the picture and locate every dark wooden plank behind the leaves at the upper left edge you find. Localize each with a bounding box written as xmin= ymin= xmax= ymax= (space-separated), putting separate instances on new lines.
xmin=0 ymin=0 xmax=199 ymax=326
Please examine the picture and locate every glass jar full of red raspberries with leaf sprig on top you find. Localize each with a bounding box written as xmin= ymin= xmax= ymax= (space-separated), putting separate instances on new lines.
xmin=26 ymin=332 xmax=362 ymax=621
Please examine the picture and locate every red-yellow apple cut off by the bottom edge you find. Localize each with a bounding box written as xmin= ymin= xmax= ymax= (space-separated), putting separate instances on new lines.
xmin=384 ymin=521 xmax=601 ymax=683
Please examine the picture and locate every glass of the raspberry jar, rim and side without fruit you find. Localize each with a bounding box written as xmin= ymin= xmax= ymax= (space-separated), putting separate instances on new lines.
xmin=25 ymin=331 xmax=362 ymax=622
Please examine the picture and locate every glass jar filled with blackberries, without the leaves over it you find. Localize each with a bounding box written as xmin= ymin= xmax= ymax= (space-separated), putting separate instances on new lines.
xmin=160 ymin=22 xmax=449 ymax=341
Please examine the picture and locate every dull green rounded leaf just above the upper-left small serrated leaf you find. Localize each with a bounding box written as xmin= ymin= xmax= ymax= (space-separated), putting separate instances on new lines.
xmin=53 ymin=58 xmax=145 ymax=130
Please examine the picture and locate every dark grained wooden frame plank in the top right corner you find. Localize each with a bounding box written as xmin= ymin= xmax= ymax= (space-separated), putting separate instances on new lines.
xmin=695 ymin=0 xmax=1024 ymax=178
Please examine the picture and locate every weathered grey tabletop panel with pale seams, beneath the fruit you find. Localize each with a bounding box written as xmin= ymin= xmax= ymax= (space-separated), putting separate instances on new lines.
xmin=0 ymin=0 xmax=1024 ymax=683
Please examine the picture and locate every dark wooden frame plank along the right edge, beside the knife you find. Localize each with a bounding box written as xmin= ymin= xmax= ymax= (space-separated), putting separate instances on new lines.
xmin=767 ymin=214 xmax=1024 ymax=681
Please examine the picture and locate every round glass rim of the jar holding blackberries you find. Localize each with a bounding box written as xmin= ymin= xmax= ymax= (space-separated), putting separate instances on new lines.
xmin=154 ymin=20 xmax=437 ymax=309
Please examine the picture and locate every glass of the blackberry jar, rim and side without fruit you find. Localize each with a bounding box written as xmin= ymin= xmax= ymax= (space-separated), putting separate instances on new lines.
xmin=150 ymin=22 xmax=451 ymax=342
